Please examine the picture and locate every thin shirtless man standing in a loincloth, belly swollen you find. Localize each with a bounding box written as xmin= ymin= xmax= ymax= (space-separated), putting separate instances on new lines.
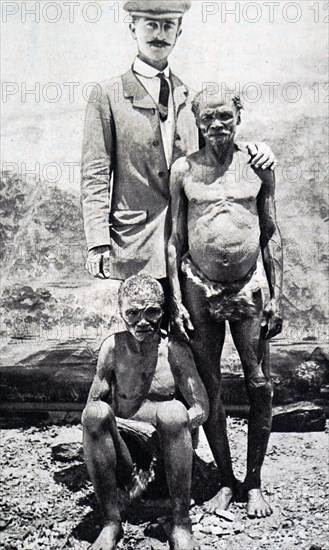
xmin=169 ymin=92 xmax=282 ymax=517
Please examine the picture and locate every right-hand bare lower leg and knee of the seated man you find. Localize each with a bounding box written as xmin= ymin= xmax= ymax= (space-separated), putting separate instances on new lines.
xmin=156 ymin=401 xmax=199 ymax=550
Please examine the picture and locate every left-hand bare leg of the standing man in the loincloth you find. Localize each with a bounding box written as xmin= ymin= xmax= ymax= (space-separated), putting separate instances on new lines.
xmin=182 ymin=279 xmax=235 ymax=512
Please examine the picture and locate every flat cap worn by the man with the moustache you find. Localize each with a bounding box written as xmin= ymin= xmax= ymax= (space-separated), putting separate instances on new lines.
xmin=123 ymin=0 xmax=192 ymax=19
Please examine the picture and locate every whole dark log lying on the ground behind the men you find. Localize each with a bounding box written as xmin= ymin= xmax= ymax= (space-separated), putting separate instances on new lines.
xmin=0 ymin=340 xmax=329 ymax=412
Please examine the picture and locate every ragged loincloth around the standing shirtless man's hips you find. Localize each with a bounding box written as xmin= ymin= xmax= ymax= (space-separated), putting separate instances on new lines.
xmin=181 ymin=254 xmax=262 ymax=321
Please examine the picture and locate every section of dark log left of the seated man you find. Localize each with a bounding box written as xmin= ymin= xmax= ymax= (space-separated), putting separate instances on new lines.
xmin=0 ymin=340 xmax=97 ymax=403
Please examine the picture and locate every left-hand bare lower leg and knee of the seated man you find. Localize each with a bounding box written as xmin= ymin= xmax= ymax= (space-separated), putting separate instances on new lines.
xmin=82 ymin=401 xmax=132 ymax=550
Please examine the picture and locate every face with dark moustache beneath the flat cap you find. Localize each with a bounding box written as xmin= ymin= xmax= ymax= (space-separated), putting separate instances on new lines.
xmin=130 ymin=17 xmax=181 ymax=62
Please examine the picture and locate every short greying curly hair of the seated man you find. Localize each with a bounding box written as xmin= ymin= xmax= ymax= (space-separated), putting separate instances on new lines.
xmin=119 ymin=275 xmax=164 ymax=309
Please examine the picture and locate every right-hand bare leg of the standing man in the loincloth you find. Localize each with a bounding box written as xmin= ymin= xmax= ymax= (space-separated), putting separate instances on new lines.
xmin=230 ymin=297 xmax=272 ymax=517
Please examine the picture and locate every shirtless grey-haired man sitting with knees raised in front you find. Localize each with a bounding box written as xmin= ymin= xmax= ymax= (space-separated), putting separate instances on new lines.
xmin=83 ymin=275 xmax=209 ymax=550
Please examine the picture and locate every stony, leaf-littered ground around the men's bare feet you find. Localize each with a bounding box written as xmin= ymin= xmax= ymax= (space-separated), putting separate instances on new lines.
xmin=0 ymin=418 xmax=329 ymax=550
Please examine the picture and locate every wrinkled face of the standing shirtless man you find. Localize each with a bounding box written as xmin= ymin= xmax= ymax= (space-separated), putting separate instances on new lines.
xmin=197 ymin=102 xmax=238 ymax=147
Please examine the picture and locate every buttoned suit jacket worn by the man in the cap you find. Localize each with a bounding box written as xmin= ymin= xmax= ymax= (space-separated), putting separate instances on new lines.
xmin=81 ymin=70 xmax=198 ymax=279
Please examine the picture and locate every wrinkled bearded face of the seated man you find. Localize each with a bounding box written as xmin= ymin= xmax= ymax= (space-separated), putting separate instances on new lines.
xmin=121 ymin=297 xmax=163 ymax=342
